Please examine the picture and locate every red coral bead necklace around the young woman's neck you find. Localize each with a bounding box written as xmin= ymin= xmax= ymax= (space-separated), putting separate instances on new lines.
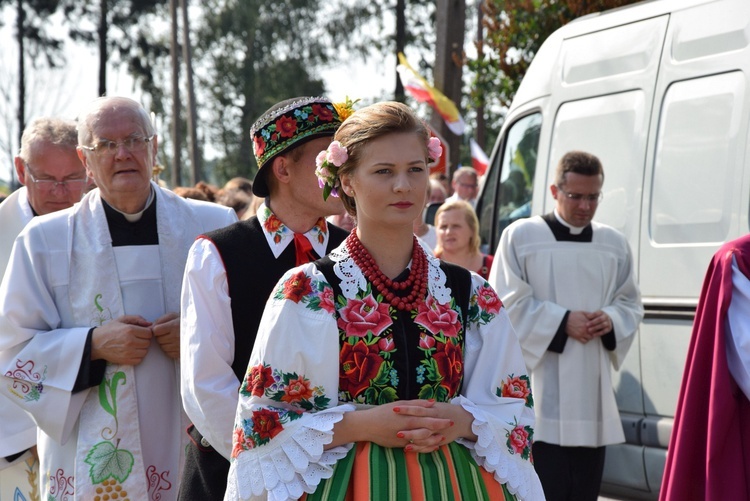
xmin=346 ymin=231 xmax=427 ymax=311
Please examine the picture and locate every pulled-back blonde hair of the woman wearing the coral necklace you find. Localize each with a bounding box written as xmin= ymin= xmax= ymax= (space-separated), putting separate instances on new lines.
xmin=334 ymin=101 xmax=430 ymax=218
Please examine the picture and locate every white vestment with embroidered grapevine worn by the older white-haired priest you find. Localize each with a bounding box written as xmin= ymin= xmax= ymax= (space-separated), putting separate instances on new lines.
xmin=0 ymin=184 xmax=236 ymax=500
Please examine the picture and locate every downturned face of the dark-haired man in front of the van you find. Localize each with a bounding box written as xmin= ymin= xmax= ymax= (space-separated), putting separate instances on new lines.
xmin=550 ymin=172 xmax=603 ymax=228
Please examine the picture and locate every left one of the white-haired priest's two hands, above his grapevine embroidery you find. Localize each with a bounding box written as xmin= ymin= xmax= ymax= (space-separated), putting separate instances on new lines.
xmin=91 ymin=315 xmax=153 ymax=365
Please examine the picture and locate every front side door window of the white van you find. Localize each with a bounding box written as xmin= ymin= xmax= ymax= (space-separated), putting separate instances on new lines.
xmin=477 ymin=113 xmax=542 ymax=248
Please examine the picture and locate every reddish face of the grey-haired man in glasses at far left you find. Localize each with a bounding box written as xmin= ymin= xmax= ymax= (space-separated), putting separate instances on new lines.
xmin=15 ymin=141 xmax=88 ymax=216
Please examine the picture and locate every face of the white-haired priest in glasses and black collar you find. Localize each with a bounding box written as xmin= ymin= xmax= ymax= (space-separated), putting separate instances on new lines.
xmin=79 ymin=107 xmax=156 ymax=207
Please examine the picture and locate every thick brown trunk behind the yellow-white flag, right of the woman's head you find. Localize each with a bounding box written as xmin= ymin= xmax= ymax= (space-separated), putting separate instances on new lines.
xmin=430 ymin=0 xmax=466 ymax=175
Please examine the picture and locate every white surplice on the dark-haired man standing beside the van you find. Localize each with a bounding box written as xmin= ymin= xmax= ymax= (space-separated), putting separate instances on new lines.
xmin=489 ymin=216 xmax=643 ymax=447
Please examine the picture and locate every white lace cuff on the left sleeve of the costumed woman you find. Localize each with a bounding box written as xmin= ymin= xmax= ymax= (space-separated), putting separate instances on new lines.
xmin=224 ymin=405 xmax=354 ymax=501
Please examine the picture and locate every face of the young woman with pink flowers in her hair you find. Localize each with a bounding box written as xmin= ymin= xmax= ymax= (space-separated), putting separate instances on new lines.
xmin=341 ymin=132 xmax=428 ymax=230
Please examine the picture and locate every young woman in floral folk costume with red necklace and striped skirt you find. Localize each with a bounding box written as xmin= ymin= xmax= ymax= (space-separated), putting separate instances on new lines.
xmin=225 ymin=102 xmax=543 ymax=500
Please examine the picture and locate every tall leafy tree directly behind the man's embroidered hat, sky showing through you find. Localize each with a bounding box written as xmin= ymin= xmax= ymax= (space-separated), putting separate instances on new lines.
xmin=195 ymin=0 xmax=378 ymax=180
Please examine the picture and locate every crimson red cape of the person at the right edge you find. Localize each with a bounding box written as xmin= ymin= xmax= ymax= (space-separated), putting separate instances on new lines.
xmin=659 ymin=235 xmax=750 ymax=501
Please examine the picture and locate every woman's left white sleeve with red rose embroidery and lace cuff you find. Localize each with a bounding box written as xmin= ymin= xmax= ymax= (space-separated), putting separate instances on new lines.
xmin=227 ymin=264 xmax=354 ymax=500
